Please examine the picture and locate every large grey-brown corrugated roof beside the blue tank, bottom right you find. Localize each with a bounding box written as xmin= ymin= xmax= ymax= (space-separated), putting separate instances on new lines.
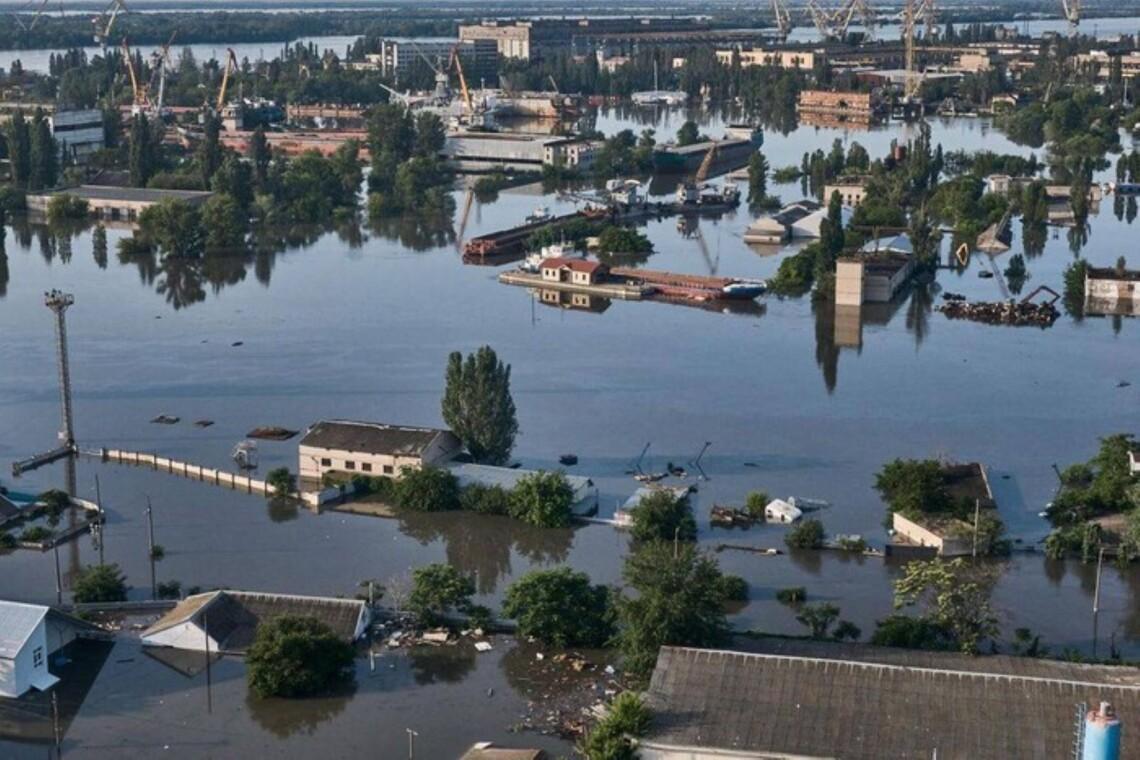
xmin=644 ymin=639 xmax=1140 ymax=760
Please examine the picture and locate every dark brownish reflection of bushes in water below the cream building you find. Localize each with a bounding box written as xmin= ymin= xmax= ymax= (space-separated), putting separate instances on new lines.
xmin=399 ymin=512 xmax=573 ymax=594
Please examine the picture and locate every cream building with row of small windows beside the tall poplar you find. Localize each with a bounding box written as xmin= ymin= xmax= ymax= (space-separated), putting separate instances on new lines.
xmin=298 ymin=419 xmax=463 ymax=480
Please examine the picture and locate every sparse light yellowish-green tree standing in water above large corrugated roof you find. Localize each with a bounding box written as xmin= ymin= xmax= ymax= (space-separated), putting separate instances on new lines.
xmin=895 ymin=557 xmax=999 ymax=654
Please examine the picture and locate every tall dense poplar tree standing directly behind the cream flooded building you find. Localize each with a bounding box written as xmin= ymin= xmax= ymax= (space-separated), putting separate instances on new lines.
xmin=442 ymin=345 xmax=519 ymax=465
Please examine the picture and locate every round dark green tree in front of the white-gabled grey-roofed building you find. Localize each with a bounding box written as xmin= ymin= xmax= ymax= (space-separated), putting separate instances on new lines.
xmin=245 ymin=615 xmax=356 ymax=698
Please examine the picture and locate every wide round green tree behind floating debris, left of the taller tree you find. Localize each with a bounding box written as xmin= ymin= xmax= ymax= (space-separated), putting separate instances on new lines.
xmin=503 ymin=567 xmax=613 ymax=648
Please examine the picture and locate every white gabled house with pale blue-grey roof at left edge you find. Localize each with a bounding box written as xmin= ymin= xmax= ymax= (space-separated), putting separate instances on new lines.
xmin=0 ymin=600 xmax=98 ymax=697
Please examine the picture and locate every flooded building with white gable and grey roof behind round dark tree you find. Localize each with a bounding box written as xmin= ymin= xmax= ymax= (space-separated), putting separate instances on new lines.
xmin=143 ymin=590 xmax=372 ymax=654
